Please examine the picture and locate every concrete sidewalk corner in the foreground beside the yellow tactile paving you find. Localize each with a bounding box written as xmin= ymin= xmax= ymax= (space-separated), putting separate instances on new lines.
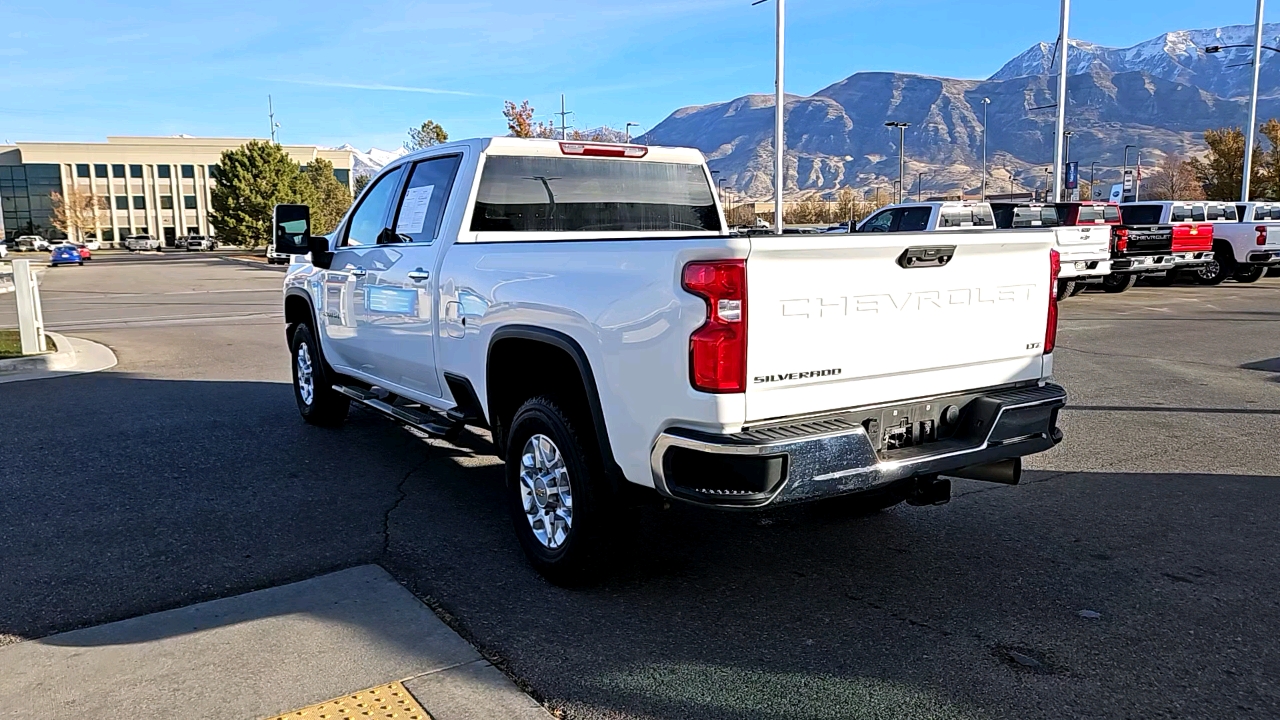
xmin=0 ymin=565 xmax=550 ymax=720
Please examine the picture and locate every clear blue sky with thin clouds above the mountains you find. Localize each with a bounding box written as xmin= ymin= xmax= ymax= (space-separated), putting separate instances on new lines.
xmin=0 ymin=0 xmax=1276 ymax=149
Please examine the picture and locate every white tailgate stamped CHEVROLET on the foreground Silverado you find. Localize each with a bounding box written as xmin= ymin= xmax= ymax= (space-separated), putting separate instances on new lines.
xmin=746 ymin=228 xmax=1055 ymax=423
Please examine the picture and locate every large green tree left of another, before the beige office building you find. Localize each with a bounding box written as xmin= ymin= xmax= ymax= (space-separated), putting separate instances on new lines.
xmin=209 ymin=140 xmax=311 ymax=247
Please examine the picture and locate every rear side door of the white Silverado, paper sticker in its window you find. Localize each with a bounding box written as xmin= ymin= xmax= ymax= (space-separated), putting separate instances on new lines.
xmin=361 ymin=152 xmax=462 ymax=397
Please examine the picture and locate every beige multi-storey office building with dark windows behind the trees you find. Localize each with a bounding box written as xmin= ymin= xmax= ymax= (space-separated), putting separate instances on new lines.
xmin=0 ymin=136 xmax=351 ymax=245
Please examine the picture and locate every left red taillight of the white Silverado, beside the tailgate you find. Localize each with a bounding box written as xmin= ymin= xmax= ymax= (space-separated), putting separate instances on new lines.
xmin=684 ymin=260 xmax=746 ymax=392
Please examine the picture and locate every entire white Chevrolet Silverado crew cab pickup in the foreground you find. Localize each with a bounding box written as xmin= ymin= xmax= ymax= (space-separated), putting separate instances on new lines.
xmin=273 ymin=137 xmax=1065 ymax=582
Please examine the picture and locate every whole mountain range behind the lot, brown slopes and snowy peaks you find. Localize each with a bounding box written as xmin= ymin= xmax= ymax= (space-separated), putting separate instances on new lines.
xmin=639 ymin=24 xmax=1280 ymax=199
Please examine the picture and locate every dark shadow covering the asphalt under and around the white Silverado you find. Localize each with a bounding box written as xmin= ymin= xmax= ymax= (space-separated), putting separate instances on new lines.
xmin=0 ymin=373 xmax=1280 ymax=719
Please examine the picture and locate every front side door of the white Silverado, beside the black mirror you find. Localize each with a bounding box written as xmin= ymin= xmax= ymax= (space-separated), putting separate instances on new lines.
xmin=319 ymin=168 xmax=404 ymax=373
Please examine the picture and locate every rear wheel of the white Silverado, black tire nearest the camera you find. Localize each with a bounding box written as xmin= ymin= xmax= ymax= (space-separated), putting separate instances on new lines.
xmin=506 ymin=397 xmax=617 ymax=585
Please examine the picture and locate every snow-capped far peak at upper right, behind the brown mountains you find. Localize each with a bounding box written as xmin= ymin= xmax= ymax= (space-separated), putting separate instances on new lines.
xmin=989 ymin=23 xmax=1280 ymax=97
